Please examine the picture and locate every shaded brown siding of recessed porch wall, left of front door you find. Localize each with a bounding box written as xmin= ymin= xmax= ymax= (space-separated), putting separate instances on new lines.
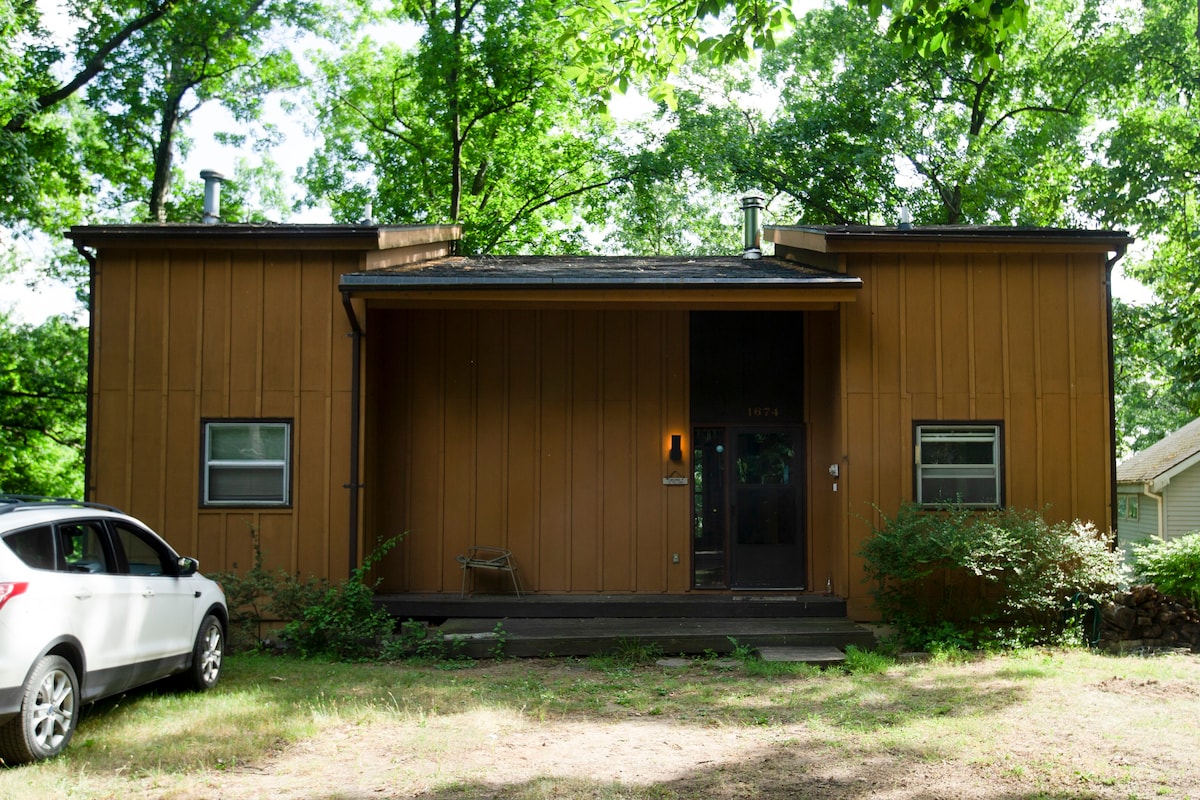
xmin=365 ymin=309 xmax=691 ymax=594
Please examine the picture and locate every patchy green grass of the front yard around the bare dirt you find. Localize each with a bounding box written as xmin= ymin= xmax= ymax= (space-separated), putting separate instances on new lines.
xmin=0 ymin=650 xmax=1200 ymax=800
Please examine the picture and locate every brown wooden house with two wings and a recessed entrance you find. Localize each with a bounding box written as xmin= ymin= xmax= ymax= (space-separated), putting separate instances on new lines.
xmin=68 ymin=219 xmax=1129 ymax=619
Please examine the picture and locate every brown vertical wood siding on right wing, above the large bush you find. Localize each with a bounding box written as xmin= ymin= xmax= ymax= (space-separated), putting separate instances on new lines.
xmin=841 ymin=252 xmax=1112 ymax=618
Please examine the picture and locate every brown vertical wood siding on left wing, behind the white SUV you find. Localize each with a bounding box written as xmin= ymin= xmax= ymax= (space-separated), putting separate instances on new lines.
xmin=89 ymin=247 xmax=360 ymax=578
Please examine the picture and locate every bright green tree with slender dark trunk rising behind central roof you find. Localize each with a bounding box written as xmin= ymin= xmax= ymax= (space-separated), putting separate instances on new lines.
xmin=305 ymin=0 xmax=618 ymax=252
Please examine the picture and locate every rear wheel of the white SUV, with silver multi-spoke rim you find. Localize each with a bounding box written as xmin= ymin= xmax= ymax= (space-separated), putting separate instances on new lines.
xmin=0 ymin=655 xmax=82 ymax=765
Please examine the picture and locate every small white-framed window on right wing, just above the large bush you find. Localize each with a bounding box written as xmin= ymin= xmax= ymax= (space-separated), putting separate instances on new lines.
xmin=914 ymin=423 xmax=1002 ymax=507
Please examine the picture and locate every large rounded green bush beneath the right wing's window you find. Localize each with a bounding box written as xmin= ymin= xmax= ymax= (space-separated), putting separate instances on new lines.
xmin=860 ymin=504 xmax=1121 ymax=646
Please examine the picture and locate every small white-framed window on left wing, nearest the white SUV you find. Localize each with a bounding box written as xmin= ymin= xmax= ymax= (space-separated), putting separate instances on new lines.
xmin=203 ymin=421 xmax=292 ymax=506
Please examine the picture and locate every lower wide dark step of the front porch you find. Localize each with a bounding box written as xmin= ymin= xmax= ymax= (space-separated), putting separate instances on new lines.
xmin=438 ymin=616 xmax=875 ymax=658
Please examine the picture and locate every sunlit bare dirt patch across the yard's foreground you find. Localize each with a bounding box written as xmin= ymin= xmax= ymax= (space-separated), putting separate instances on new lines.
xmin=121 ymin=656 xmax=1200 ymax=800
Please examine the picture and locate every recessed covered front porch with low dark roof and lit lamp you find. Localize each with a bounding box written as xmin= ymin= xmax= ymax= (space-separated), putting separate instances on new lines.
xmin=341 ymin=257 xmax=860 ymax=604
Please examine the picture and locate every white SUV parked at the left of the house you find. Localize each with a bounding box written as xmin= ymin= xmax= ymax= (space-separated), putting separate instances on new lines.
xmin=0 ymin=495 xmax=229 ymax=765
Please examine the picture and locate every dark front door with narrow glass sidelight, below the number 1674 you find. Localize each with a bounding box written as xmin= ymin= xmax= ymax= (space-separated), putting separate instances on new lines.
xmin=692 ymin=426 xmax=806 ymax=589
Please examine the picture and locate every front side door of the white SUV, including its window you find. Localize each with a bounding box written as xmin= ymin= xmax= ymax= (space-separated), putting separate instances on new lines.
xmin=112 ymin=519 xmax=196 ymax=680
